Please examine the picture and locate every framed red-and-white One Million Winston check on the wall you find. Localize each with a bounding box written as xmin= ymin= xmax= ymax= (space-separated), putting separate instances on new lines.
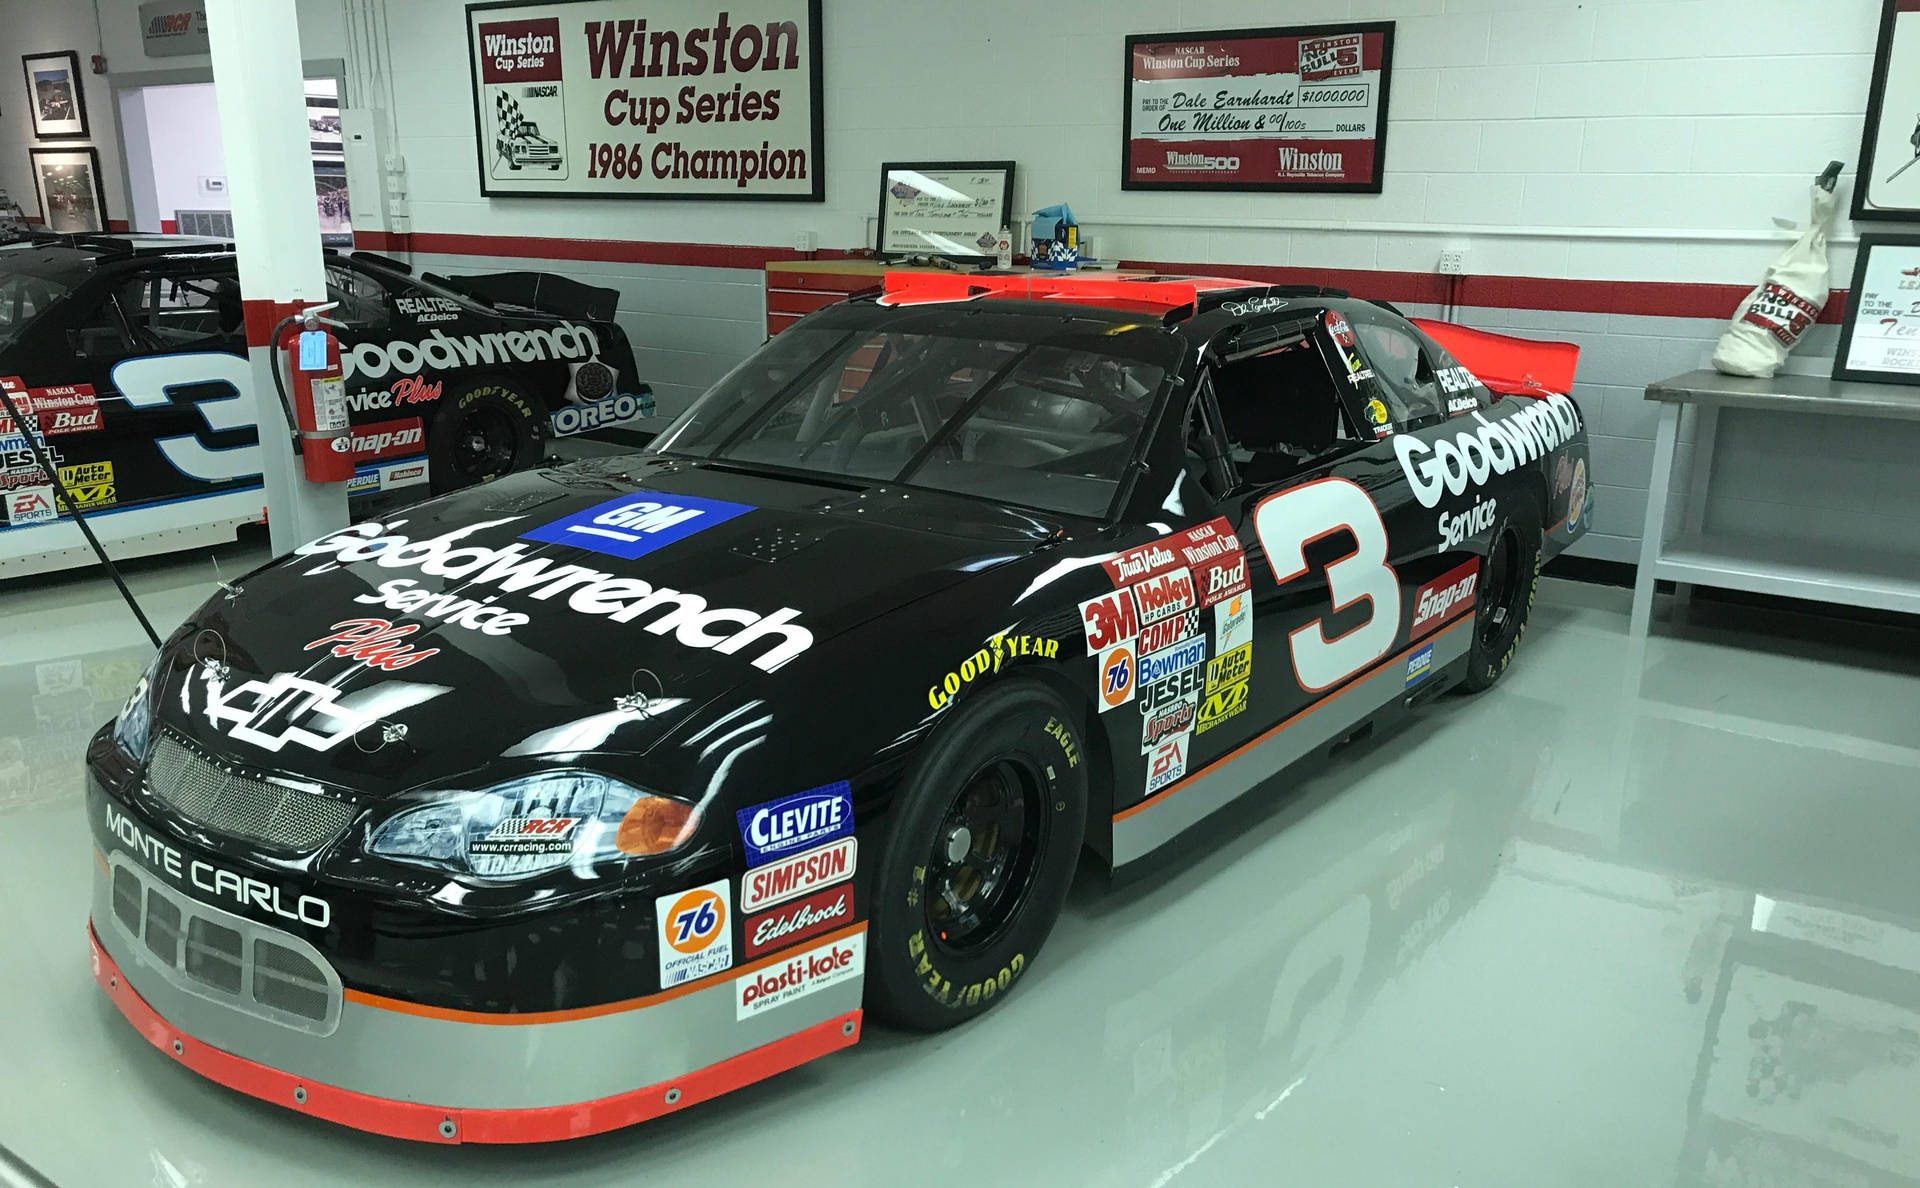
xmin=1119 ymin=21 xmax=1394 ymax=194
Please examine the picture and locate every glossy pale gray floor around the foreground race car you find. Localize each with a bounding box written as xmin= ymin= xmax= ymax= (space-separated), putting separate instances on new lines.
xmin=0 ymin=555 xmax=1920 ymax=1188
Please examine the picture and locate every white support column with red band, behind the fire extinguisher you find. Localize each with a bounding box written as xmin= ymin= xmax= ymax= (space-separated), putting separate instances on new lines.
xmin=207 ymin=0 xmax=348 ymax=553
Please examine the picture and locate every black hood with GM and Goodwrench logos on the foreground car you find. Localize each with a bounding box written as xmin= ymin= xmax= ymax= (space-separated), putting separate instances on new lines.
xmin=156 ymin=455 xmax=1062 ymax=795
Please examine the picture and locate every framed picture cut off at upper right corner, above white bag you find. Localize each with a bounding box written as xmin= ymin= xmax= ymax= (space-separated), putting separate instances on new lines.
xmin=1853 ymin=0 xmax=1920 ymax=221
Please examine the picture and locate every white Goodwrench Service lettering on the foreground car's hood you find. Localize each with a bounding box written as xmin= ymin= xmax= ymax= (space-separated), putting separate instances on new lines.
xmin=294 ymin=516 xmax=814 ymax=672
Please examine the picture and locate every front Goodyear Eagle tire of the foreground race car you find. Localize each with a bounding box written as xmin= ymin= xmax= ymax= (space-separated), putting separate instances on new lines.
xmin=866 ymin=679 xmax=1087 ymax=1031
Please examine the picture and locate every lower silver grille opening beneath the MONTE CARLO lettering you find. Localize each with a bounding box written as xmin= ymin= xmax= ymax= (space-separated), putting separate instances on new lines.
xmin=109 ymin=854 xmax=344 ymax=1036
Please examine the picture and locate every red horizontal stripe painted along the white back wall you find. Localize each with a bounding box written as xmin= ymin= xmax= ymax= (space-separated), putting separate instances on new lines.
xmin=353 ymin=230 xmax=1843 ymax=322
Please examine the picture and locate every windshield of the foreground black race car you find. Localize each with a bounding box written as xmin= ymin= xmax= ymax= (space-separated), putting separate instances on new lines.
xmin=655 ymin=326 xmax=1177 ymax=516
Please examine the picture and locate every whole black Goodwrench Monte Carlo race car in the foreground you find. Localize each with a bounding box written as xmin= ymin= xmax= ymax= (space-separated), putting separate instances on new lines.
xmin=86 ymin=274 xmax=1590 ymax=1142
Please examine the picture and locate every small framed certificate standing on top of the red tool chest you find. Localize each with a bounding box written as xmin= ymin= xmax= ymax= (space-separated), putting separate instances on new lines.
xmin=876 ymin=161 xmax=1014 ymax=259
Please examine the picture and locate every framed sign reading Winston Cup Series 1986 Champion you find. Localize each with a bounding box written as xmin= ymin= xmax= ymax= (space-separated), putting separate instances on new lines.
xmin=467 ymin=0 xmax=826 ymax=202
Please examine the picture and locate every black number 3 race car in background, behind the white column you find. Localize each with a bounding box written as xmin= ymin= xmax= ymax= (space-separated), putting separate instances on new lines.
xmin=0 ymin=234 xmax=653 ymax=576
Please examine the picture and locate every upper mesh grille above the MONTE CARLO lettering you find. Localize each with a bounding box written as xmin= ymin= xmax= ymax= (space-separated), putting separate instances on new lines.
xmin=146 ymin=735 xmax=353 ymax=852
